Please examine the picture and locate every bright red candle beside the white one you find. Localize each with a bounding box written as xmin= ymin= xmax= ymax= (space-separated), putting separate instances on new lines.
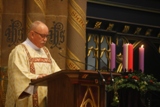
xmin=128 ymin=44 xmax=133 ymax=72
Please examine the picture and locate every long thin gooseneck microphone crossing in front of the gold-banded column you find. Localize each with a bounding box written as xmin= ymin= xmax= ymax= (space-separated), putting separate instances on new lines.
xmin=58 ymin=53 xmax=106 ymax=83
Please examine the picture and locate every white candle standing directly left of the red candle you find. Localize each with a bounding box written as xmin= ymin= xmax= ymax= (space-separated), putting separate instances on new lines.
xmin=123 ymin=44 xmax=128 ymax=71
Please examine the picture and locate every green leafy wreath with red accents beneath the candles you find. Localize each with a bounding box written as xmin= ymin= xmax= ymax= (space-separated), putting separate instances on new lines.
xmin=107 ymin=71 xmax=160 ymax=106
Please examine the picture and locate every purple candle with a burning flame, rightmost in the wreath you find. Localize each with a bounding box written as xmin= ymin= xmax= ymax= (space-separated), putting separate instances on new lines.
xmin=139 ymin=45 xmax=144 ymax=72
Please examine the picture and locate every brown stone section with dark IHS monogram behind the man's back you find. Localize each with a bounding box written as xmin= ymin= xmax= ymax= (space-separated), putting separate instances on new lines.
xmin=1 ymin=0 xmax=25 ymax=66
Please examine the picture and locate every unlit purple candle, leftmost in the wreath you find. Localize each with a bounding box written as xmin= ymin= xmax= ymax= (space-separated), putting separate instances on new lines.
xmin=111 ymin=42 xmax=116 ymax=71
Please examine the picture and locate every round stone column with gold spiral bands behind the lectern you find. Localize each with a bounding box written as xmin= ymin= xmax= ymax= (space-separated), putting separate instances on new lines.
xmin=67 ymin=0 xmax=87 ymax=70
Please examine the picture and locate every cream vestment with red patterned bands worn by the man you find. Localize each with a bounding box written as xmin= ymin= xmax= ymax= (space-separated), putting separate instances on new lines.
xmin=5 ymin=44 xmax=60 ymax=107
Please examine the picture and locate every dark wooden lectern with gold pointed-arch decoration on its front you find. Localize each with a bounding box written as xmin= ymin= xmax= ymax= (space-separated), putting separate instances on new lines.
xmin=31 ymin=70 xmax=118 ymax=107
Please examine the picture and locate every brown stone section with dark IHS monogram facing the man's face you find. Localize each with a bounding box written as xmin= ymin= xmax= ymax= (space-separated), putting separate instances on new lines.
xmin=46 ymin=0 xmax=68 ymax=69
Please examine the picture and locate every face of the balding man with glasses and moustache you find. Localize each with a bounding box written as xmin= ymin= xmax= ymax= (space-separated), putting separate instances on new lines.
xmin=31 ymin=25 xmax=48 ymax=48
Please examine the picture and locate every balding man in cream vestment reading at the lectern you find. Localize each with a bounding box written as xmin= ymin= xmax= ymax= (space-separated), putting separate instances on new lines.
xmin=5 ymin=21 xmax=61 ymax=107
